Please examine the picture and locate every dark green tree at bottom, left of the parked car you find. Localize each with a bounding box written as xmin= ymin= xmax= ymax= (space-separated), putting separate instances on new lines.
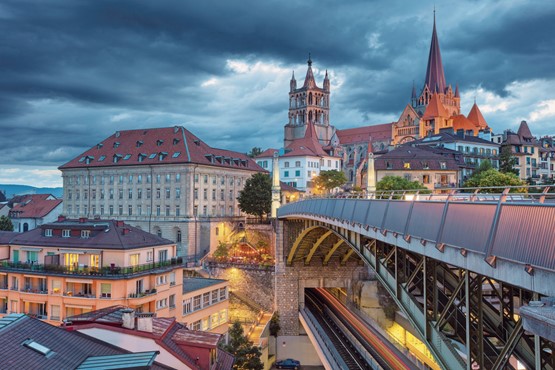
xmin=222 ymin=321 xmax=264 ymax=370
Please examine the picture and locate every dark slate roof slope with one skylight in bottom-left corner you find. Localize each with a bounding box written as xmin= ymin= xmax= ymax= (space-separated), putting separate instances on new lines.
xmin=0 ymin=314 xmax=172 ymax=369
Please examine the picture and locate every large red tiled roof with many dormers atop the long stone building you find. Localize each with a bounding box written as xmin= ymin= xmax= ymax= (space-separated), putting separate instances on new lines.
xmin=59 ymin=126 xmax=264 ymax=172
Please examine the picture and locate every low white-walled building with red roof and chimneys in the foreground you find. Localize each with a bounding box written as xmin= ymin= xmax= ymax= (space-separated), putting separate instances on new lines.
xmin=65 ymin=306 xmax=234 ymax=370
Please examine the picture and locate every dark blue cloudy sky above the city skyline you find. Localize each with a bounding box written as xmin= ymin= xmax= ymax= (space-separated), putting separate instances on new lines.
xmin=0 ymin=0 xmax=555 ymax=186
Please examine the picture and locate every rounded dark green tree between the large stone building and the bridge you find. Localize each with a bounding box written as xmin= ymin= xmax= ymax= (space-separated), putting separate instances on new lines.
xmin=237 ymin=173 xmax=272 ymax=219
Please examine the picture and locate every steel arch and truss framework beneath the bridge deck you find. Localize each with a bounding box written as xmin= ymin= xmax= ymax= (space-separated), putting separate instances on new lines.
xmin=286 ymin=220 xmax=555 ymax=369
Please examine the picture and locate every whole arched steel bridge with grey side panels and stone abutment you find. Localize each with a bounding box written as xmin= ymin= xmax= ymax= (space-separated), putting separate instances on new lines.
xmin=276 ymin=188 xmax=555 ymax=369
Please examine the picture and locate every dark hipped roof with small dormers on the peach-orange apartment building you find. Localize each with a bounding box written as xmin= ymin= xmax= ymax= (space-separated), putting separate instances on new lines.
xmin=10 ymin=219 xmax=175 ymax=250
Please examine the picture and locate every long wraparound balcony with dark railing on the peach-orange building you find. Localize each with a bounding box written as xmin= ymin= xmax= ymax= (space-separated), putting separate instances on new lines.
xmin=0 ymin=257 xmax=185 ymax=278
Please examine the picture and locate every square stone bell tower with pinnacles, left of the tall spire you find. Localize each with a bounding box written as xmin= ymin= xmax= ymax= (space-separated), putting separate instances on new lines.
xmin=284 ymin=54 xmax=333 ymax=147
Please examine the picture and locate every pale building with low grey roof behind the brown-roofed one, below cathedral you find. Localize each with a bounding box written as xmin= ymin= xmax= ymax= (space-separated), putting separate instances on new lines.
xmin=404 ymin=129 xmax=500 ymax=186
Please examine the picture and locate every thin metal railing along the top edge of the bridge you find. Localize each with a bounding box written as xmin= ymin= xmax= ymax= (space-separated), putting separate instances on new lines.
xmin=298 ymin=185 xmax=555 ymax=203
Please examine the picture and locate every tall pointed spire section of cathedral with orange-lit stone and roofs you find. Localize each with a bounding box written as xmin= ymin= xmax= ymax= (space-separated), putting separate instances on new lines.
xmin=392 ymin=13 xmax=490 ymax=145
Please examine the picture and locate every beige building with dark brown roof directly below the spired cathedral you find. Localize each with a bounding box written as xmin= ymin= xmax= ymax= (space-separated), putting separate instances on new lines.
xmin=374 ymin=145 xmax=464 ymax=190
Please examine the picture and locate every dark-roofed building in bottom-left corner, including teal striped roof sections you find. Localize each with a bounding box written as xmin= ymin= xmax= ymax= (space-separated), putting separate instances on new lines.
xmin=0 ymin=313 xmax=172 ymax=370
